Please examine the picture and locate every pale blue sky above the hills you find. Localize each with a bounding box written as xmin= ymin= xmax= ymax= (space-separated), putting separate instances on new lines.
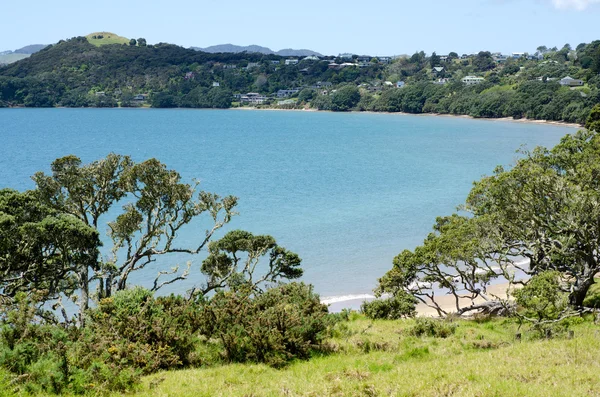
xmin=0 ymin=0 xmax=600 ymax=55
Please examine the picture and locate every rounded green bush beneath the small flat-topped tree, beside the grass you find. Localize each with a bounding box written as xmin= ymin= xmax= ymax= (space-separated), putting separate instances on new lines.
xmin=202 ymin=283 xmax=330 ymax=367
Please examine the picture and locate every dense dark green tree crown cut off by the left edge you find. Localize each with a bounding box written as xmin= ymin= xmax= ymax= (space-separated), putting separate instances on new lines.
xmin=0 ymin=189 xmax=100 ymax=300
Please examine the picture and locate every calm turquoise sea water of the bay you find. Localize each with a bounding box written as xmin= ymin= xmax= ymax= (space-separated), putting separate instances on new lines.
xmin=0 ymin=109 xmax=575 ymax=304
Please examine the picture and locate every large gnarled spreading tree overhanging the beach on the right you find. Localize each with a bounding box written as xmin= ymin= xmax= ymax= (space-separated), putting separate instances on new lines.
xmin=379 ymin=131 xmax=600 ymax=314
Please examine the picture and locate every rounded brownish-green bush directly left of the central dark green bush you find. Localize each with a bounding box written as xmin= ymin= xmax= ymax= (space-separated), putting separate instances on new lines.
xmin=80 ymin=287 xmax=200 ymax=374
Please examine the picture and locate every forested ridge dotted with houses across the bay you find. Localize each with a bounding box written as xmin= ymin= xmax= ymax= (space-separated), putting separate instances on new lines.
xmin=0 ymin=37 xmax=600 ymax=124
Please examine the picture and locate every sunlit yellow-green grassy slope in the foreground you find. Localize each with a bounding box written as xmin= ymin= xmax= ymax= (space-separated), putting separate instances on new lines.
xmin=118 ymin=316 xmax=600 ymax=397
